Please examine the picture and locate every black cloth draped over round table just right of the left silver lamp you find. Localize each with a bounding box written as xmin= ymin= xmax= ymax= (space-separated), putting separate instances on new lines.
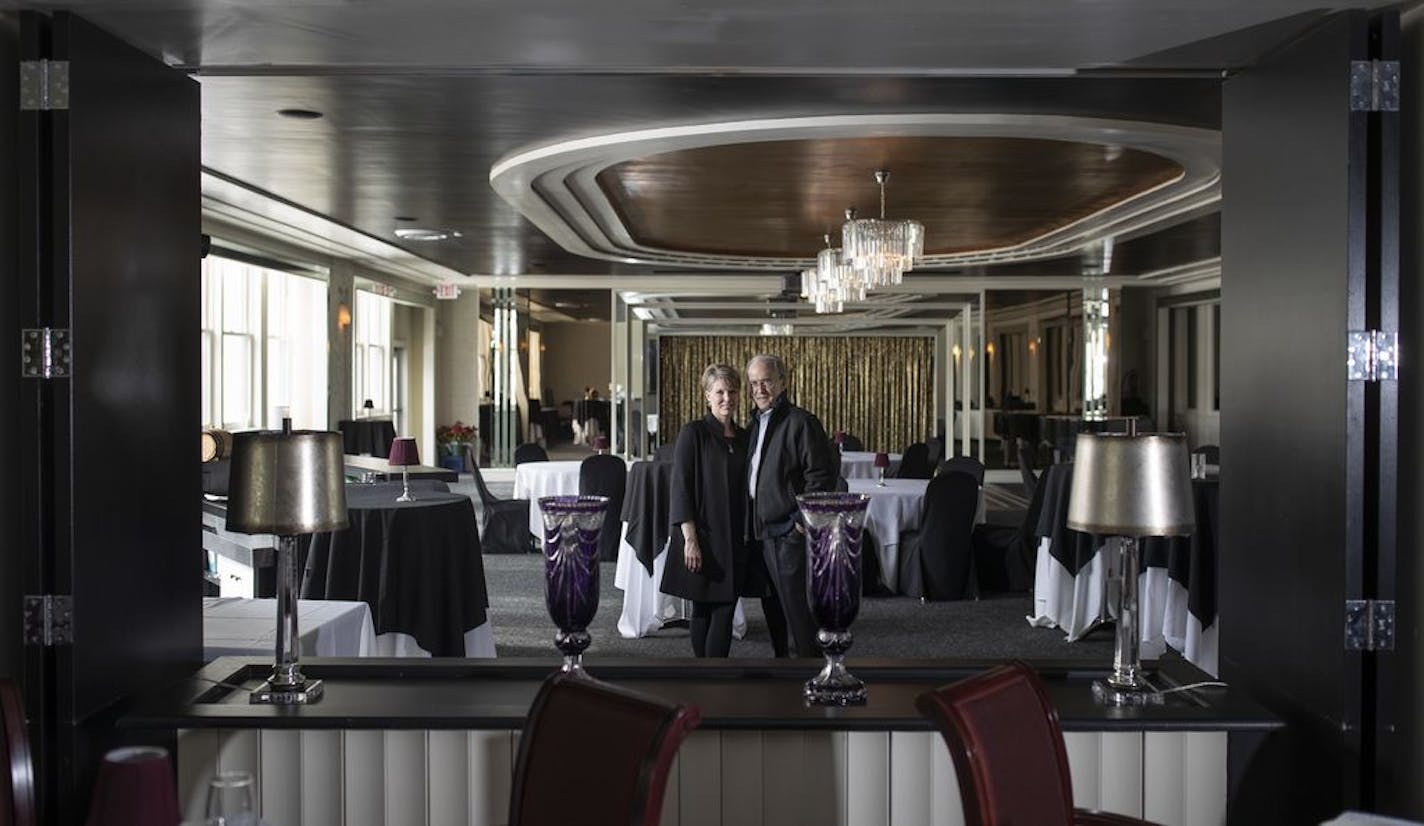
xmin=302 ymin=481 xmax=490 ymax=657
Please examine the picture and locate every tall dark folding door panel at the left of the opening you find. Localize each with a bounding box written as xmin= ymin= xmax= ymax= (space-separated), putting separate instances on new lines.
xmin=50 ymin=14 xmax=202 ymax=722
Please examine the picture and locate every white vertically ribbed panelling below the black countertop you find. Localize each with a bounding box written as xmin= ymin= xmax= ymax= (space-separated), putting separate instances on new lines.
xmin=178 ymin=729 xmax=1226 ymax=826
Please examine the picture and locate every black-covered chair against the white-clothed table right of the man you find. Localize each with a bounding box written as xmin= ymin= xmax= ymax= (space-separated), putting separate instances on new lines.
xmin=920 ymin=473 xmax=980 ymax=600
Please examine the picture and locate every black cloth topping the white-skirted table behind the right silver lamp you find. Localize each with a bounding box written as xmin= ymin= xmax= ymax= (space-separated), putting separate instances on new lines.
xmin=1035 ymin=461 xmax=1220 ymax=628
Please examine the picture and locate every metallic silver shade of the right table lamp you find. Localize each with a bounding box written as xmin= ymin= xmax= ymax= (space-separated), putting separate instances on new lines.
xmin=1068 ymin=433 xmax=1196 ymax=537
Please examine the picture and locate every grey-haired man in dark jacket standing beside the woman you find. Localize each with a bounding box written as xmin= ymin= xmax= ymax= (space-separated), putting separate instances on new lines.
xmin=746 ymin=353 xmax=836 ymax=657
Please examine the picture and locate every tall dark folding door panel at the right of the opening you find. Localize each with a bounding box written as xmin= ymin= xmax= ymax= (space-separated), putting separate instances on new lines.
xmin=1219 ymin=13 xmax=1367 ymax=823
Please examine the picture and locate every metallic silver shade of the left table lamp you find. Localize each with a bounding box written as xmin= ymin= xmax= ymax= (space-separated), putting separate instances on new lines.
xmin=228 ymin=430 xmax=346 ymax=535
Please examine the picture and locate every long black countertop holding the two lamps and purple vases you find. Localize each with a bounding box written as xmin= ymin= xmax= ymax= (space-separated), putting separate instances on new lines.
xmin=120 ymin=657 xmax=1282 ymax=731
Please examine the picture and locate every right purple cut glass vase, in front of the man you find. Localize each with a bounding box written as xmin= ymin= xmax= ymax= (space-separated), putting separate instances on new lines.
xmin=796 ymin=493 xmax=870 ymax=705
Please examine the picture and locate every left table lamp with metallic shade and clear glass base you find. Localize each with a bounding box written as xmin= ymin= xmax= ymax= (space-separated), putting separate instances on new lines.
xmin=228 ymin=430 xmax=346 ymax=705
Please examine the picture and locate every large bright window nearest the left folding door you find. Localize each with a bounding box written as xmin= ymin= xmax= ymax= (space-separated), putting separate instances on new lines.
xmin=199 ymin=255 xmax=326 ymax=430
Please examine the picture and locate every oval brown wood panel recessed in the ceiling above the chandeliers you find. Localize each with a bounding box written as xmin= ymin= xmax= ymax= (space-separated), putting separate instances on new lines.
xmin=597 ymin=137 xmax=1183 ymax=258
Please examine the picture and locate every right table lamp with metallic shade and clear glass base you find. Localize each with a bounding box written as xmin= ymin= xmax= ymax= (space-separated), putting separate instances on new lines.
xmin=1068 ymin=433 xmax=1196 ymax=705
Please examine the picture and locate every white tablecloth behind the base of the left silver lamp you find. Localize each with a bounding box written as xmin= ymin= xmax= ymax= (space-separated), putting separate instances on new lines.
xmin=202 ymin=597 xmax=376 ymax=661
